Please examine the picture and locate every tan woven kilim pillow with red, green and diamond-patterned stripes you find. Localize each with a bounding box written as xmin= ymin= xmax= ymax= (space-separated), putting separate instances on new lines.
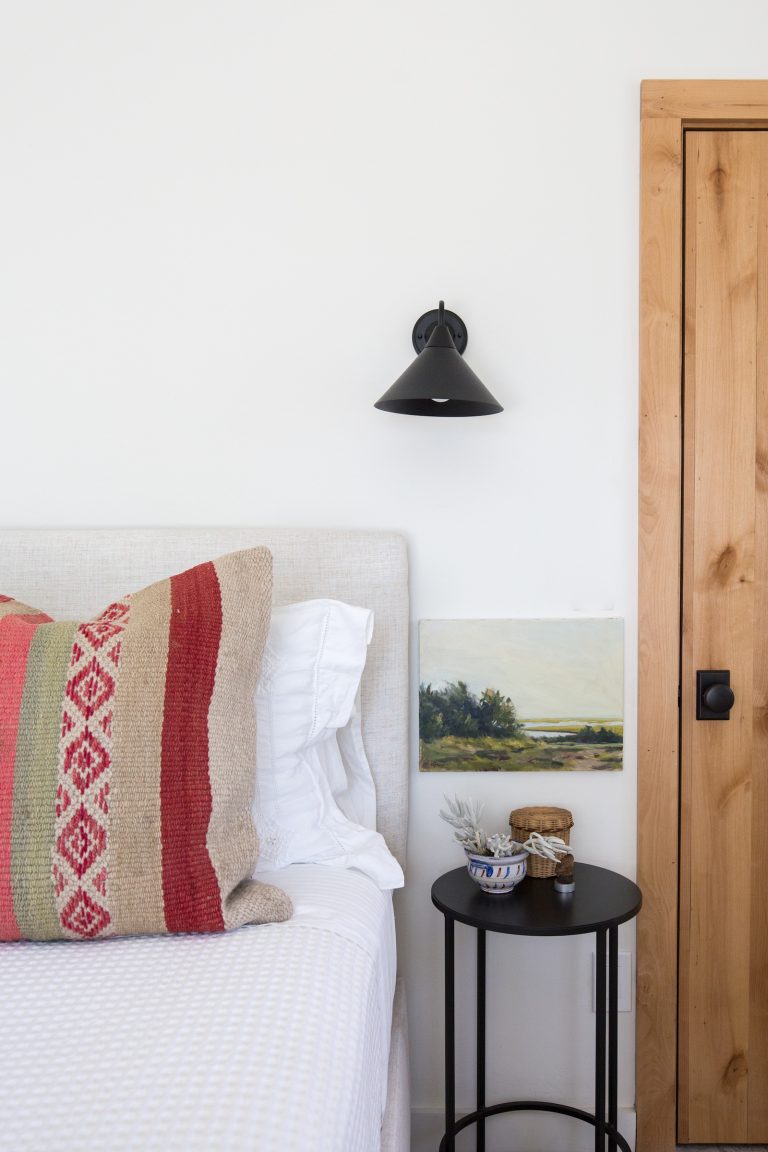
xmin=0 ymin=548 xmax=291 ymax=940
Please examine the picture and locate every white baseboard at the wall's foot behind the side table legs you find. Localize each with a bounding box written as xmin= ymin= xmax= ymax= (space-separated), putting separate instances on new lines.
xmin=411 ymin=1108 xmax=636 ymax=1152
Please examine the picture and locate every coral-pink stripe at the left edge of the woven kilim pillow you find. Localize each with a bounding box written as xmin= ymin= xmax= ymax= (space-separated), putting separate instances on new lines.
xmin=0 ymin=617 xmax=50 ymax=940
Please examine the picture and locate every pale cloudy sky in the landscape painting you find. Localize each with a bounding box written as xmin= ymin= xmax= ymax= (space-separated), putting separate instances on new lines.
xmin=419 ymin=619 xmax=624 ymax=720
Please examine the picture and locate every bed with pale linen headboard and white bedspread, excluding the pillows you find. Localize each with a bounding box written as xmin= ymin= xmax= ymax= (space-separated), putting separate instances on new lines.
xmin=0 ymin=529 xmax=410 ymax=1152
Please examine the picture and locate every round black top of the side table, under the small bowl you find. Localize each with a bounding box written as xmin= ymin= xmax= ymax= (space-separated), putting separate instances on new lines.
xmin=432 ymin=864 xmax=642 ymax=935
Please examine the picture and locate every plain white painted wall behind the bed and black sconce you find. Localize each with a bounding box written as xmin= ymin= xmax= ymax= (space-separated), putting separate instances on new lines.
xmin=0 ymin=0 xmax=768 ymax=1149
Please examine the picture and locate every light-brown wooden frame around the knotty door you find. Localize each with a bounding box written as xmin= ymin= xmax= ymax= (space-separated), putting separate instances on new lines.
xmin=637 ymin=81 xmax=768 ymax=1152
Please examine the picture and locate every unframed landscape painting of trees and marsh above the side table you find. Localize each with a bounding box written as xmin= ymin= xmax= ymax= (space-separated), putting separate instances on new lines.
xmin=419 ymin=617 xmax=624 ymax=772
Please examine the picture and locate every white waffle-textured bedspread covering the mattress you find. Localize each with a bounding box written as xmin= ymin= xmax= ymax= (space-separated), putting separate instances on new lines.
xmin=0 ymin=865 xmax=396 ymax=1152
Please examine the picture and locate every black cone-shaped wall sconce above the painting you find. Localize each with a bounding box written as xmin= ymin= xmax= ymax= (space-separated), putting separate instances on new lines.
xmin=374 ymin=301 xmax=503 ymax=416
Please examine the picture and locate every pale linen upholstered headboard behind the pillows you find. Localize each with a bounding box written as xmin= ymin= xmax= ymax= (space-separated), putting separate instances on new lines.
xmin=0 ymin=528 xmax=409 ymax=864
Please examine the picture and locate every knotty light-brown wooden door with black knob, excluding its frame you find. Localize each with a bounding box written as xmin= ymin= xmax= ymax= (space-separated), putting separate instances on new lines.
xmin=677 ymin=129 xmax=768 ymax=1144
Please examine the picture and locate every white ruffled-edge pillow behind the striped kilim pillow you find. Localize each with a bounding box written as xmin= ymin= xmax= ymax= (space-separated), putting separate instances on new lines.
xmin=253 ymin=600 xmax=403 ymax=888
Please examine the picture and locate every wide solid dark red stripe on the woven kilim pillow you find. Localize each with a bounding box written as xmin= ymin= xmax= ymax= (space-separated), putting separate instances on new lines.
xmin=160 ymin=563 xmax=225 ymax=932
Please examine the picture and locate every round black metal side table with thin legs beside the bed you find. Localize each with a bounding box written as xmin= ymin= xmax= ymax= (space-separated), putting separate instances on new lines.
xmin=432 ymin=864 xmax=642 ymax=1152
